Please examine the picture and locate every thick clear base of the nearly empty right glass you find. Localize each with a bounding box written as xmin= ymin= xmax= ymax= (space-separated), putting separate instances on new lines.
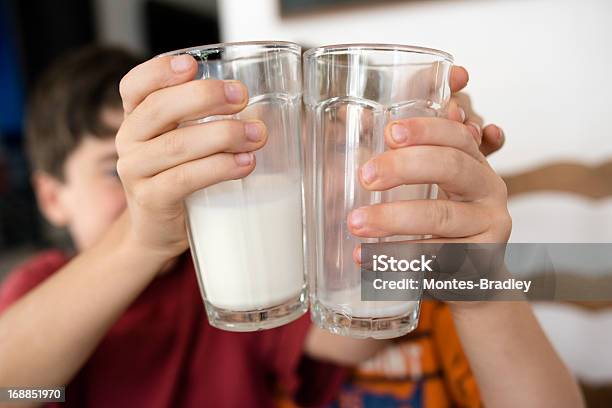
xmin=311 ymin=300 xmax=420 ymax=339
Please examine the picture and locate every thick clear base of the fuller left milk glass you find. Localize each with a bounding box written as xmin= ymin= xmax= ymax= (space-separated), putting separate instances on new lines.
xmin=204 ymin=288 xmax=308 ymax=332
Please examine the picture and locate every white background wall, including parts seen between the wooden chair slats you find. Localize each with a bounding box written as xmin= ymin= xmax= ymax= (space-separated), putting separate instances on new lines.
xmin=219 ymin=0 xmax=612 ymax=383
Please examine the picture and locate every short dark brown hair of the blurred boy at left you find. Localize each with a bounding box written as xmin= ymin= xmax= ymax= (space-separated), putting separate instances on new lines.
xmin=26 ymin=46 xmax=142 ymax=180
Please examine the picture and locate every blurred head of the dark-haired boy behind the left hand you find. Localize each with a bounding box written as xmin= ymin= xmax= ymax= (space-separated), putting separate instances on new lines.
xmin=26 ymin=47 xmax=143 ymax=250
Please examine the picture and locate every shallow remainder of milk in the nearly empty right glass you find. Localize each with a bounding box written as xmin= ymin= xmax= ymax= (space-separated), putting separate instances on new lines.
xmin=320 ymin=286 xmax=419 ymax=318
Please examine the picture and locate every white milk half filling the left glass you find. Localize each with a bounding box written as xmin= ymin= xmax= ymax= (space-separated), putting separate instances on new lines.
xmin=186 ymin=174 xmax=304 ymax=311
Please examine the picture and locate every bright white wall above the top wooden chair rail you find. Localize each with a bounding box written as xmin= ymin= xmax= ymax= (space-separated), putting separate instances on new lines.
xmin=219 ymin=0 xmax=612 ymax=172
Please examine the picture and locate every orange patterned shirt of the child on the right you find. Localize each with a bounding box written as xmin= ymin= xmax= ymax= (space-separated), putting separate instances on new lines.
xmin=280 ymin=301 xmax=482 ymax=408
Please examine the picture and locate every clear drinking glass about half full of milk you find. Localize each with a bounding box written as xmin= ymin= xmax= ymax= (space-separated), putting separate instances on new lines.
xmin=164 ymin=42 xmax=308 ymax=331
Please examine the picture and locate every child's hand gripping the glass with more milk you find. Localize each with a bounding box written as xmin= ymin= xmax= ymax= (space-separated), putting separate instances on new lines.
xmin=116 ymin=55 xmax=266 ymax=258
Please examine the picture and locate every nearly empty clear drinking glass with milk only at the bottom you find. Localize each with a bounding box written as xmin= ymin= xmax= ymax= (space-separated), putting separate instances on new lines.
xmin=304 ymin=44 xmax=453 ymax=338
